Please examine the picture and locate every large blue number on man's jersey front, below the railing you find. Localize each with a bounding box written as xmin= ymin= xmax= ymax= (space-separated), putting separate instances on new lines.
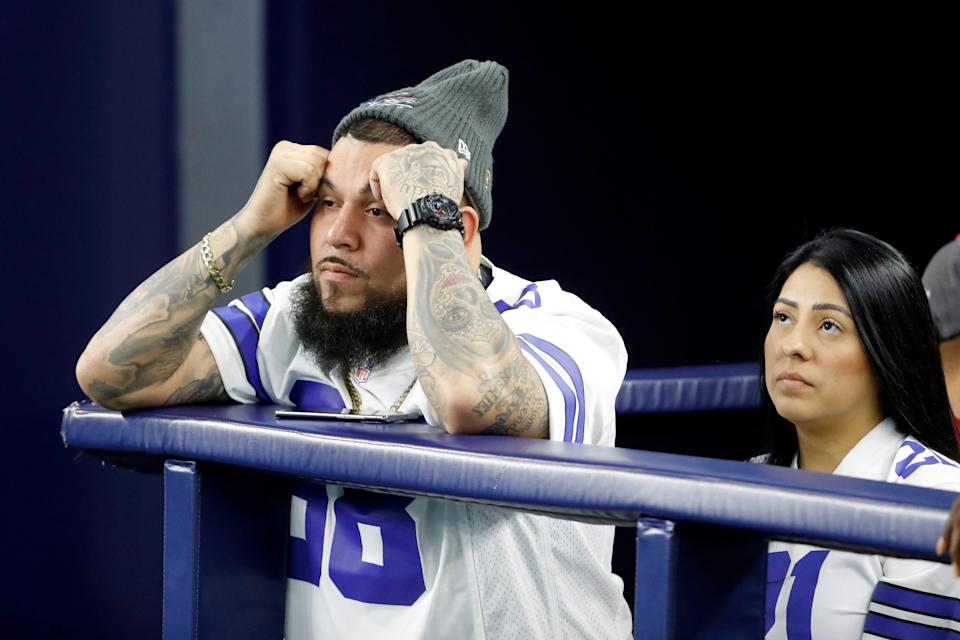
xmin=289 ymin=486 xmax=426 ymax=605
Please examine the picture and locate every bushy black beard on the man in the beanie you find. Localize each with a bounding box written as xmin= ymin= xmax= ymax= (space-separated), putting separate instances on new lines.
xmin=290 ymin=274 xmax=407 ymax=371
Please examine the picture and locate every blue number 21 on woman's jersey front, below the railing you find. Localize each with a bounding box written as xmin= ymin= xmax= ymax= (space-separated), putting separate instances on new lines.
xmin=763 ymin=549 xmax=830 ymax=640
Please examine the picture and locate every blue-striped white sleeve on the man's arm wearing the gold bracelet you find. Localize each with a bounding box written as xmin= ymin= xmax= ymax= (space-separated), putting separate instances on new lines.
xmin=200 ymin=290 xmax=274 ymax=404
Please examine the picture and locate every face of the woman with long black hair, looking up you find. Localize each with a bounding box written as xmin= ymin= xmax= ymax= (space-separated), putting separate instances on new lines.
xmin=763 ymin=262 xmax=883 ymax=431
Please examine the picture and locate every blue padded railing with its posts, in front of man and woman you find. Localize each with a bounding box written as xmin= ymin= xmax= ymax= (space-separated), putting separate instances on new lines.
xmin=62 ymin=404 xmax=955 ymax=638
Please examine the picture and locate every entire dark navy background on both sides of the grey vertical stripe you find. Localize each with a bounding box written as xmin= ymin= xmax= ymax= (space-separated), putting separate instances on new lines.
xmin=0 ymin=0 xmax=960 ymax=638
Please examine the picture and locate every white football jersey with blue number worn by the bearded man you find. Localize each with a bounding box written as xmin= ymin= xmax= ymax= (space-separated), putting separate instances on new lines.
xmin=202 ymin=262 xmax=631 ymax=640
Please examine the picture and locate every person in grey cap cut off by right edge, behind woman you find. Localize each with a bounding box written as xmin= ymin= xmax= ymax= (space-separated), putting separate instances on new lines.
xmin=923 ymin=240 xmax=960 ymax=576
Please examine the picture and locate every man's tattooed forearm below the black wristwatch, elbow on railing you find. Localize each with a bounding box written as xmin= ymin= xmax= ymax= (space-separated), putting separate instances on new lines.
xmin=404 ymin=225 xmax=548 ymax=438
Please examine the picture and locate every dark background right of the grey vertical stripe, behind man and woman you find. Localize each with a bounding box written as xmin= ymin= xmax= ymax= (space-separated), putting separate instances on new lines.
xmin=268 ymin=2 xmax=960 ymax=366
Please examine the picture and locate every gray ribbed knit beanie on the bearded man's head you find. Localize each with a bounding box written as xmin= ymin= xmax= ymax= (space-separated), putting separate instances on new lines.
xmin=333 ymin=60 xmax=508 ymax=229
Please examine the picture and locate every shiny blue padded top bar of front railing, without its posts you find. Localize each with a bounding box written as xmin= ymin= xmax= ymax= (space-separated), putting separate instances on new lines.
xmin=62 ymin=403 xmax=955 ymax=559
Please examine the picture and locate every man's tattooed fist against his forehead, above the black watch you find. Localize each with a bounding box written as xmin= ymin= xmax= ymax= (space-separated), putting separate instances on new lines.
xmin=370 ymin=141 xmax=467 ymax=220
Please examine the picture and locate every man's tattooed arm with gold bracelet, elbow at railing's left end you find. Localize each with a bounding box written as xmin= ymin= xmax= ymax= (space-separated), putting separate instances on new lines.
xmin=77 ymin=217 xmax=268 ymax=409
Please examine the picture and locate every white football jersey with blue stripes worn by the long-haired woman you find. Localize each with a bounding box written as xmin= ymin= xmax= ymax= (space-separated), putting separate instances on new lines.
xmin=765 ymin=418 xmax=960 ymax=640
